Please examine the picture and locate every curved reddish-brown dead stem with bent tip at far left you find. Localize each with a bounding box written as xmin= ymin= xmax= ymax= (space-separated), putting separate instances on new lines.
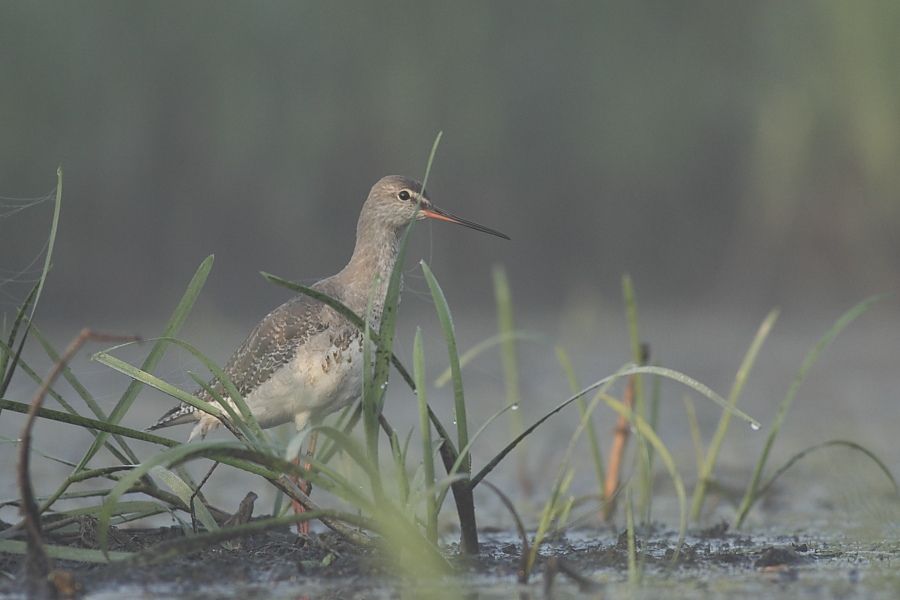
xmin=17 ymin=329 xmax=137 ymax=598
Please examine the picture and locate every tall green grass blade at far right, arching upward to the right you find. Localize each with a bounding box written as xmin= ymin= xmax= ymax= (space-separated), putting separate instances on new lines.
xmin=735 ymin=295 xmax=884 ymax=528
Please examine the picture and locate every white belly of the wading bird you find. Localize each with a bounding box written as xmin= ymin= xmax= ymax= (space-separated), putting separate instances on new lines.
xmin=246 ymin=340 xmax=363 ymax=429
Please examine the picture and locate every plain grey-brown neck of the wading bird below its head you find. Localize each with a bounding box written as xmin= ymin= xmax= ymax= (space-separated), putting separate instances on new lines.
xmin=337 ymin=219 xmax=400 ymax=321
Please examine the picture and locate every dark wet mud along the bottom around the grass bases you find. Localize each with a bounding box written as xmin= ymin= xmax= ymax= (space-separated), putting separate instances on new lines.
xmin=0 ymin=521 xmax=900 ymax=599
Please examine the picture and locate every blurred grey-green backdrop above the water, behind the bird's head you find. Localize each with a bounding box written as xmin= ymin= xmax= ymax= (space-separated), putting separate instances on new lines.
xmin=0 ymin=0 xmax=900 ymax=326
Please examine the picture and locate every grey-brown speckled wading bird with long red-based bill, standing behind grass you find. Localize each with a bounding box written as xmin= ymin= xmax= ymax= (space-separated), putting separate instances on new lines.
xmin=150 ymin=175 xmax=509 ymax=528
